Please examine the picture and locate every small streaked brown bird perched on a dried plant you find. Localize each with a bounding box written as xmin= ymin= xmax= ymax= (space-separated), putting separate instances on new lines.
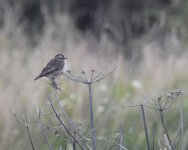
xmin=34 ymin=54 xmax=67 ymax=83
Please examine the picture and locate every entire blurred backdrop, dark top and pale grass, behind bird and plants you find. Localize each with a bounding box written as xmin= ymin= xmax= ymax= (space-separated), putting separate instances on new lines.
xmin=0 ymin=0 xmax=188 ymax=150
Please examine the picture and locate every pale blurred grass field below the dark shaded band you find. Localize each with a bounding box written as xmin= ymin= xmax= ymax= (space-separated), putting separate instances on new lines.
xmin=0 ymin=4 xmax=188 ymax=150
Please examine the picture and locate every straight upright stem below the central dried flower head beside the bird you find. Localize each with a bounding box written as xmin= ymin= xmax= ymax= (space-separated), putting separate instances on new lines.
xmin=88 ymin=84 xmax=96 ymax=150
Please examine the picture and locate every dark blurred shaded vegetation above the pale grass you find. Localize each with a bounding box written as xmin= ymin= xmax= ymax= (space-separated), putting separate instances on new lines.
xmin=0 ymin=0 xmax=182 ymax=58
